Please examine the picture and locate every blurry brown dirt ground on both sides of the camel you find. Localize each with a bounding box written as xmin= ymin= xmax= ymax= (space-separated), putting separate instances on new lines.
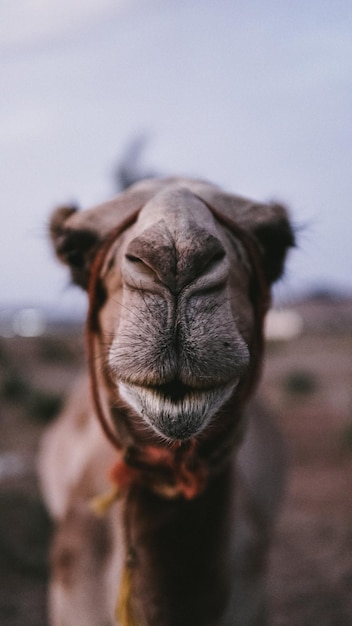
xmin=0 ymin=316 xmax=352 ymax=626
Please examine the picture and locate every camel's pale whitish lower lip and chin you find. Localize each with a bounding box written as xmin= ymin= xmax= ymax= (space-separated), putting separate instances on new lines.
xmin=119 ymin=380 xmax=238 ymax=440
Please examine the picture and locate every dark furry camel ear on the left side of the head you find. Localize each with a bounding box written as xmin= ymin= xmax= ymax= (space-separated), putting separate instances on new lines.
xmin=49 ymin=206 xmax=99 ymax=289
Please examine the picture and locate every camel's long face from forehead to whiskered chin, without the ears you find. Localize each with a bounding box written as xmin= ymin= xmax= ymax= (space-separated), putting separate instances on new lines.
xmin=101 ymin=189 xmax=251 ymax=440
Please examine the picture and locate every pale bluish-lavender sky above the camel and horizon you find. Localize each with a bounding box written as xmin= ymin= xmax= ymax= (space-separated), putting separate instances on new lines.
xmin=0 ymin=0 xmax=352 ymax=313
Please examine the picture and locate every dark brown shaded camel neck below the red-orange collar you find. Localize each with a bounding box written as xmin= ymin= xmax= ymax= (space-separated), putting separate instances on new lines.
xmin=119 ymin=461 xmax=235 ymax=626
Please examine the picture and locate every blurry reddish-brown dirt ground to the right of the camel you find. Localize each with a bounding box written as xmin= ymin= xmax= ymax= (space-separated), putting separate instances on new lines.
xmin=264 ymin=335 xmax=352 ymax=626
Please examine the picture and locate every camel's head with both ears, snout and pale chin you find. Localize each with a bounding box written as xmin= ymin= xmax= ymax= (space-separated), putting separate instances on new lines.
xmin=50 ymin=179 xmax=294 ymax=441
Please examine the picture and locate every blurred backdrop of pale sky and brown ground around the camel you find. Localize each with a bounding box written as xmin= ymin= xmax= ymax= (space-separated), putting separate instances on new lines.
xmin=0 ymin=0 xmax=352 ymax=626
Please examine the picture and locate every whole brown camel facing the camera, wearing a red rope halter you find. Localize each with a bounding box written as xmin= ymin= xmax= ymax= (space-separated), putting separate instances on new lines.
xmin=39 ymin=178 xmax=294 ymax=626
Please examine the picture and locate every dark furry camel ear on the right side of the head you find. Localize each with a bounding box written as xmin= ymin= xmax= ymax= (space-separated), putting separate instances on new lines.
xmin=246 ymin=204 xmax=295 ymax=284
